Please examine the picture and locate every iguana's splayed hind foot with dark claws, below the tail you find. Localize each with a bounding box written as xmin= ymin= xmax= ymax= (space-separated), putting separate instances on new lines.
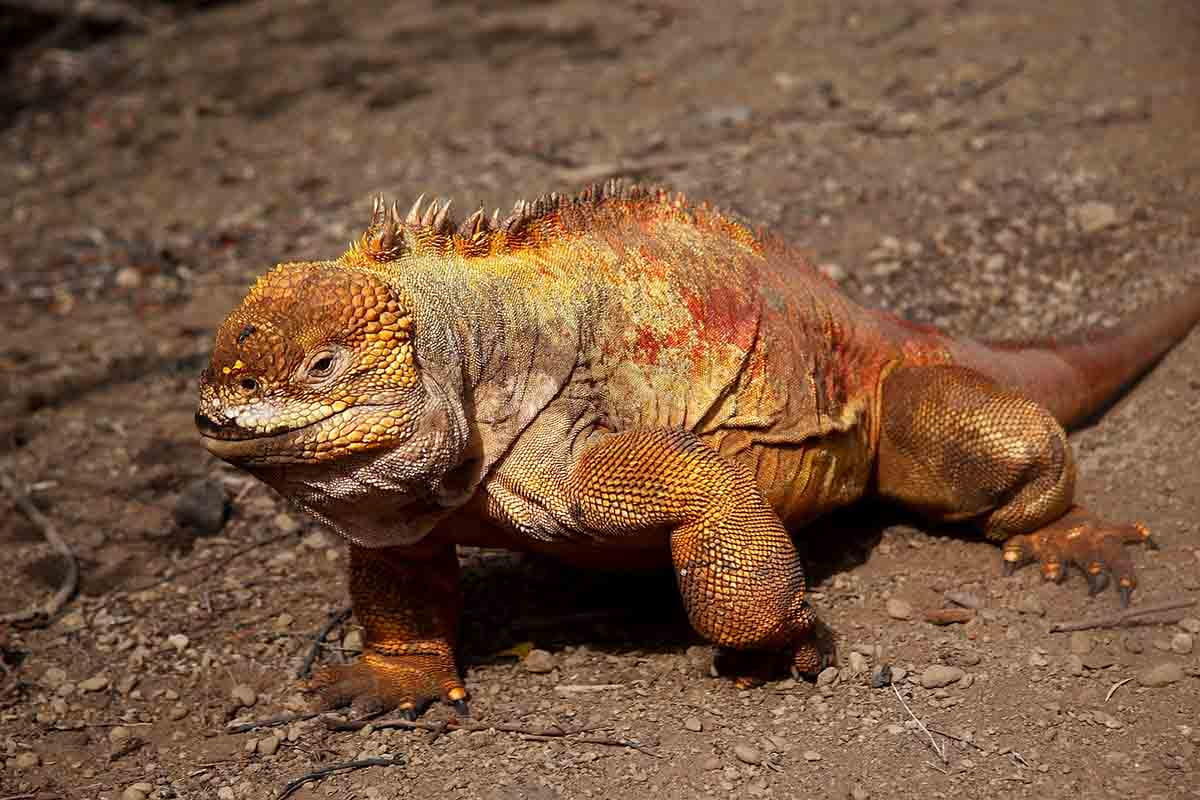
xmin=1004 ymin=506 xmax=1154 ymax=607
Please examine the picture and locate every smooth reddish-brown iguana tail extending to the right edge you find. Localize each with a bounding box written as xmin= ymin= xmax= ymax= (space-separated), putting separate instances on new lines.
xmin=949 ymin=287 xmax=1200 ymax=428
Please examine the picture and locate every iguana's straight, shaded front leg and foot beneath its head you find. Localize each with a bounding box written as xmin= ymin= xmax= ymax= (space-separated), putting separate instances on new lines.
xmin=308 ymin=545 xmax=467 ymax=718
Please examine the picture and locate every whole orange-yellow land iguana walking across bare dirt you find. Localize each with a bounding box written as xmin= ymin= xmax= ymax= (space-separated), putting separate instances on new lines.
xmin=196 ymin=182 xmax=1200 ymax=717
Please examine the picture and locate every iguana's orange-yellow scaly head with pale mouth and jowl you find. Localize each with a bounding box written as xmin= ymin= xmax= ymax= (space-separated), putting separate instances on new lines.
xmin=196 ymin=260 xmax=466 ymax=539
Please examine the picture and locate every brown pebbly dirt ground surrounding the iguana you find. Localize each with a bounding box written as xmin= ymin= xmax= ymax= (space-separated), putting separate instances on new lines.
xmin=0 ymin=0 xmax=1200 ymax=800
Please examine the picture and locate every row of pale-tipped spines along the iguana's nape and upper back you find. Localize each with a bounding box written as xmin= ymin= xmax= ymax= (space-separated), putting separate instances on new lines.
xmin=347 ymin=180 xmax=708 ymax=264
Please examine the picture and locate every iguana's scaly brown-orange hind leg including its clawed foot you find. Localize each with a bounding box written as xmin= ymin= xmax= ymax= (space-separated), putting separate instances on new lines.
xmin=877 ymin=366 xmax=1150 ymax=604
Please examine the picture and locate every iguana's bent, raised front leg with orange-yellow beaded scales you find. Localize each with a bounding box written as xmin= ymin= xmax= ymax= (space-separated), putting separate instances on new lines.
xmin=565 ymin=429 xmax=821 ymax=673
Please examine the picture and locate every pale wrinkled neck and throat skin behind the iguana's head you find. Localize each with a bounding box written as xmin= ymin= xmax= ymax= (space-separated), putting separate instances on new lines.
xmin=256 ymin=264 xmax=578 ymax=547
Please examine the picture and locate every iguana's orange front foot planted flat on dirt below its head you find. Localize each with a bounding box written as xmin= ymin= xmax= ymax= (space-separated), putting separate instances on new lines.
xmin=304 ymin=652 xmax=468 ymax=720
